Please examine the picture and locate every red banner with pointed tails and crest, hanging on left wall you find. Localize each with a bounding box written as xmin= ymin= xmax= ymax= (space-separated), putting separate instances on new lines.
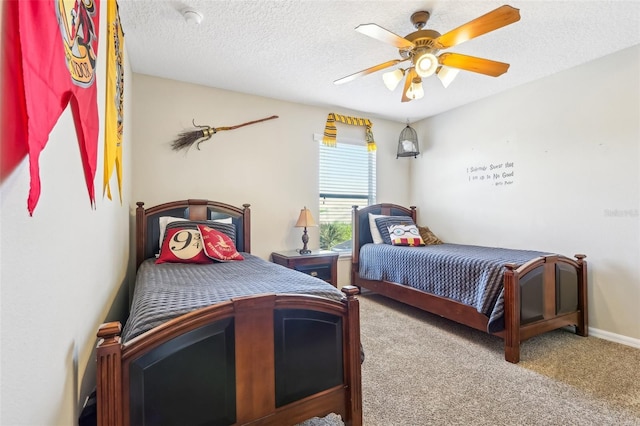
xmin=1 ymin=0 xmax=100 ymax=214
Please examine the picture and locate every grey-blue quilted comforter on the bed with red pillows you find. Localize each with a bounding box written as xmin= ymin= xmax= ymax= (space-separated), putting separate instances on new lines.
xmin=122 ymin=253 xmax=344 ymax=342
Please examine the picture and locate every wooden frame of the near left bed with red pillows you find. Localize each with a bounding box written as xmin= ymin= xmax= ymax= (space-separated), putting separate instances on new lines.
xmin=97 ymin=200 xmax=362 ymax=426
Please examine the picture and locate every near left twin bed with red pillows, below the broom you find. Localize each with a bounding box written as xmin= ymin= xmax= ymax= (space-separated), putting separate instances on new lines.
xmin=97 ymin=200 xmax=362 ymax=426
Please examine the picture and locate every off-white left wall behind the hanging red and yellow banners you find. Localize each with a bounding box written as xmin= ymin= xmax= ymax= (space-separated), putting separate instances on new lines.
xmin=0 ymin=2 xmax=132 ymax=425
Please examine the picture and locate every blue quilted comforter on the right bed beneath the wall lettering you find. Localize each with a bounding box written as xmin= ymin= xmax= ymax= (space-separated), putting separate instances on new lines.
xmin=359 ymin=244 xmax=549 ymax=333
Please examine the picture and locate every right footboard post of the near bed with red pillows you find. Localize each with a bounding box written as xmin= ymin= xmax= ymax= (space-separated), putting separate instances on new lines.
xmin=341 ymin=285 xmax=362 ymax=426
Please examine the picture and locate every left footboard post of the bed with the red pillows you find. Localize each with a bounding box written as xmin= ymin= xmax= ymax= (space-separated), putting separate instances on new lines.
xmin=96 ymin=321 xmax=123 ymax=426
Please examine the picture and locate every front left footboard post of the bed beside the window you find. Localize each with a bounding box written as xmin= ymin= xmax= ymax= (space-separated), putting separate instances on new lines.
xmin=504 ymin=263 xmax=520 ymax=364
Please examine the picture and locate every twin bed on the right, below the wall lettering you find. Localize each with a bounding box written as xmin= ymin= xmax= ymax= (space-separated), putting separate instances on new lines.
xmin=351 ymin=204 xmax=588 ymax=363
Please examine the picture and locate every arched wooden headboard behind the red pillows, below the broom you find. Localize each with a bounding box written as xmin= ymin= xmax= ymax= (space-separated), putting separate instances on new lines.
xmin=136 ymin=200 xmax=251 ymax=269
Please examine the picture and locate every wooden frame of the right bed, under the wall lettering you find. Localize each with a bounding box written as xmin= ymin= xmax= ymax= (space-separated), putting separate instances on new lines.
xmin=351 ymin=204 xmax=588 ymax=363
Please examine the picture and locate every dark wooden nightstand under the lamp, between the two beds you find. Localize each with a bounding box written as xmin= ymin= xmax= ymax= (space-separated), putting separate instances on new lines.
xmin=271 ymin=250 xmax=338 ymax=287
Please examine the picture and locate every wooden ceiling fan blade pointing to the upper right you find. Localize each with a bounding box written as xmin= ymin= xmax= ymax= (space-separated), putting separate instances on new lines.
xmin=435 ymin=5 xmax=520 ymax=49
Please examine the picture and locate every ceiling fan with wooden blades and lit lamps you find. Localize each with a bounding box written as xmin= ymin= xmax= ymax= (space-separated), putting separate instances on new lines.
xmin=334 ymin=5 xmax=520 ymax=102
